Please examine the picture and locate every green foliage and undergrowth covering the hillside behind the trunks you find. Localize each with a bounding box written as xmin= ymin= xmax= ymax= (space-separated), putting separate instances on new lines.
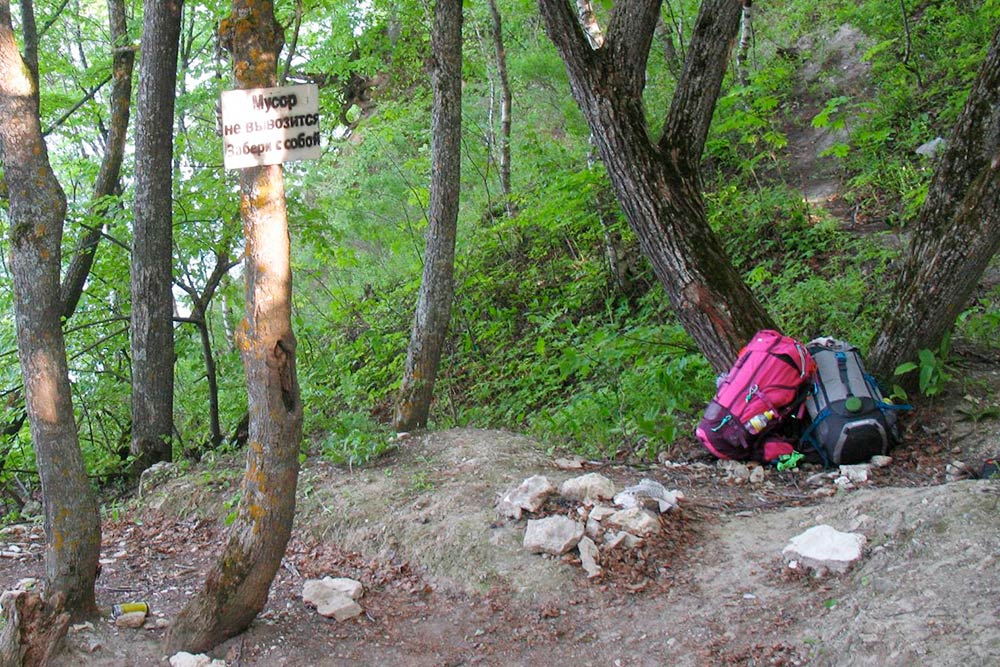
xmin=0 ymin=0 xmax=1000 ymax=500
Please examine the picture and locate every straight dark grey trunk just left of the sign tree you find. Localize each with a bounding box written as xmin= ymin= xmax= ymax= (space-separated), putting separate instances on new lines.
xmin=131 ymin=0 xmax=182 ymax=479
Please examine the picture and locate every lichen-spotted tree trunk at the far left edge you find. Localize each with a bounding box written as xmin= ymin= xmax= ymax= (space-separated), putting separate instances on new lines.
xmin=0 ymin=0 xmax=101 ymax=616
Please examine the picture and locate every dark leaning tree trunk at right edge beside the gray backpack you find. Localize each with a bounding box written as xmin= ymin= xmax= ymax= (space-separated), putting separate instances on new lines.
xmin=868 ymin=30 xmax=1000 ymax=378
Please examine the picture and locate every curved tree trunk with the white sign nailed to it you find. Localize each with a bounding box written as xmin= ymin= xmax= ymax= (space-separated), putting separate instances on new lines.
xmin=167 ymin=0 xmax=302 ymax=652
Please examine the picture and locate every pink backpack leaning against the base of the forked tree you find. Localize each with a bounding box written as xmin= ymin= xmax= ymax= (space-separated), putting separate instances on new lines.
xmin=695 ymin=329 xmax=816 ymax=462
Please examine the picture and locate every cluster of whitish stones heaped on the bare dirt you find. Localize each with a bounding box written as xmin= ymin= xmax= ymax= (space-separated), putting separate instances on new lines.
xmin=497 ymin=473 xmax=684 ymax=578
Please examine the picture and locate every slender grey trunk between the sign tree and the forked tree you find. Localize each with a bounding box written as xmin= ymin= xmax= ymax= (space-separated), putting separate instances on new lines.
xmin=393 ymin=0 xmax=462 ymax=431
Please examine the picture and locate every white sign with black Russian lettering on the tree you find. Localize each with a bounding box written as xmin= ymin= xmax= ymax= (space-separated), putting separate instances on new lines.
xmin=222 ymin=84 xmax=321 ymax=169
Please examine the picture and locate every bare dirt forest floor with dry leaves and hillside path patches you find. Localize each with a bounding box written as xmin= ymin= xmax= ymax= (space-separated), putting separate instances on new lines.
xmin=0 ymin=18 xmax=1000 ymax=667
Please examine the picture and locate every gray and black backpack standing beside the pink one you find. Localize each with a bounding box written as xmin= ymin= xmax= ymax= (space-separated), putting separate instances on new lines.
xmin=802 ymin=338 xmax=909 ymax=466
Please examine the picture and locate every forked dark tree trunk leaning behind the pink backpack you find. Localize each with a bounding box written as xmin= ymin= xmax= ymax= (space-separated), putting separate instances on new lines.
xmin=539 ymin=0 xmax=774 ymax=371
